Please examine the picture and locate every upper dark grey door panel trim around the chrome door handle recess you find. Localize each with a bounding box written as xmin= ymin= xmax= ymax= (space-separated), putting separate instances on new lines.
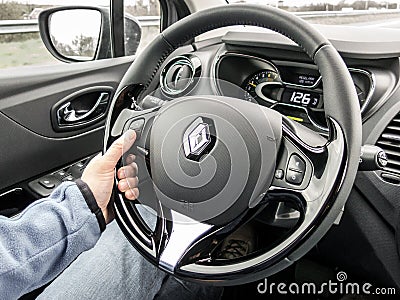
xmin=0 ymin=57 xmax=132 ymax=138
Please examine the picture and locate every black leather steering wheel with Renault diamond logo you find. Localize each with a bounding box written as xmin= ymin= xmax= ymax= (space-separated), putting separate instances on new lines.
xmin=104 ymin=4 xmax=361 ymax=285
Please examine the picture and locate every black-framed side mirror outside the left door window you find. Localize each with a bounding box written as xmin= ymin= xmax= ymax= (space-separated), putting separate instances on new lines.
xmin=39 ymin=6 xmax=142 ymax=62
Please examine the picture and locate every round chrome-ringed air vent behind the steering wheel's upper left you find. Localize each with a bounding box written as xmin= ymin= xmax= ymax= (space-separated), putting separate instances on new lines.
xmin=160 ymin=56 xmax=201 ymax=97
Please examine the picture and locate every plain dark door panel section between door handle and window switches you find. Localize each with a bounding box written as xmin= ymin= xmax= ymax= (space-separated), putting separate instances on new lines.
xmin=0 ymin=114 xmax=103 ymax=190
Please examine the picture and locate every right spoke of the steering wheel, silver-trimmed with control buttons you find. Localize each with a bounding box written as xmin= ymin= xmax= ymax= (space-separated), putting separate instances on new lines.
xmin=271 ymin=119 xmax=345 ymax=202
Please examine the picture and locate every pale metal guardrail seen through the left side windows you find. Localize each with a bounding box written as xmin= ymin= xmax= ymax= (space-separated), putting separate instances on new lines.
xmin=0 ymin=16 xmax=160 ymax=35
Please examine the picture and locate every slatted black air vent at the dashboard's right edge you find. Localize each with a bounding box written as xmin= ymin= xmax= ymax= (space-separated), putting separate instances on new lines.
xmin=376 ymin=113 xmax=400 ymax=174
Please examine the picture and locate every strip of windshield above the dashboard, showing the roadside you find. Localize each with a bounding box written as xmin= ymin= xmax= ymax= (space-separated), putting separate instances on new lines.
xmin=227 ymin=0 xmax=400 ymax=28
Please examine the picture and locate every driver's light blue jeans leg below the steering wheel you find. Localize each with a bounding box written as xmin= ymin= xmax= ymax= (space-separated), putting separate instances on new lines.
xmin=37 ymin=221 xmax=223 ymax=300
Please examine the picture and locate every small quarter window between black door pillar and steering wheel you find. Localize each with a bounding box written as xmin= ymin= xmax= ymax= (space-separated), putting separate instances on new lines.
xmin=124 ymin=0 xmax=160 ymax=53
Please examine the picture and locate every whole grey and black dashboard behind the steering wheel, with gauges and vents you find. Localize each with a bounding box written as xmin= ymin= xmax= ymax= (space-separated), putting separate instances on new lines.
xmin=152 ymin=26 xmax=400 ymax=288
